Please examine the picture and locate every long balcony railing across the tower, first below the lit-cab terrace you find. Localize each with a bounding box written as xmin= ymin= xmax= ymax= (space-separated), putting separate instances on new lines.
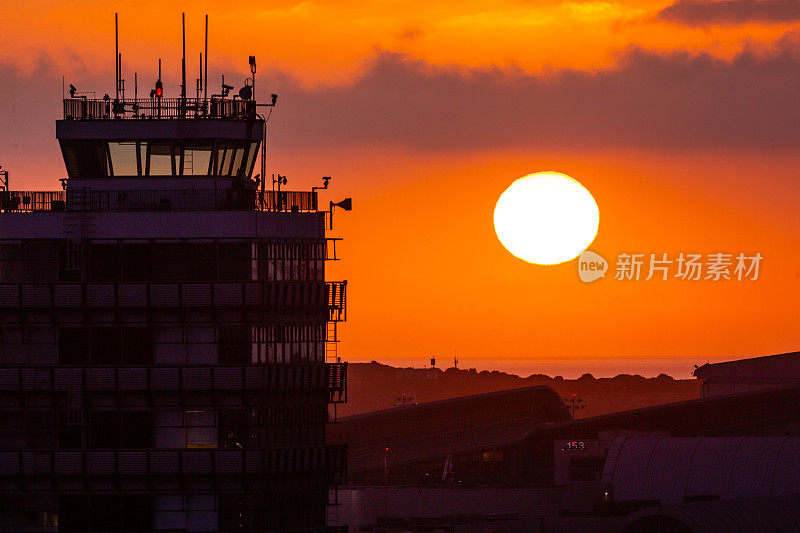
xmin=0 ymin=281 xmax=347 ymax=321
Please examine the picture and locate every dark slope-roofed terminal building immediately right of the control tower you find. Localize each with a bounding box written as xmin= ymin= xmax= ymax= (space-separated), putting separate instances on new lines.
xmin=329 ymin=386 xmax=570 ymax=484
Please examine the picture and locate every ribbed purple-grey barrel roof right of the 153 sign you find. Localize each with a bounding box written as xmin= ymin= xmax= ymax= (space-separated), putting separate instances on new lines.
xmin=603 ymin=437 xmax=800 ymax=504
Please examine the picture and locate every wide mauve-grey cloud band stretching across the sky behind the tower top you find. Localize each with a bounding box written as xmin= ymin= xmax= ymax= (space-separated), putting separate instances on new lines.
xmin=0 ymin=36 xmax=800 ymax=183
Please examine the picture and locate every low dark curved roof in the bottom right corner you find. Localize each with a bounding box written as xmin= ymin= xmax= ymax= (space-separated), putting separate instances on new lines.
xmin=622 ymin=496 xmax=800 ymax=533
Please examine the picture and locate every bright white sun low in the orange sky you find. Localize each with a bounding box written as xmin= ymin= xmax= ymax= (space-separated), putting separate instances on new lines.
xmin=494 ymin=172 xmax=600 ymax=265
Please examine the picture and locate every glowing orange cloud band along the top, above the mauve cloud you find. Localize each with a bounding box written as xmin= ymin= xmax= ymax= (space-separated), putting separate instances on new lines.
xmin=0 ymin=0 xmax=798 ymax=87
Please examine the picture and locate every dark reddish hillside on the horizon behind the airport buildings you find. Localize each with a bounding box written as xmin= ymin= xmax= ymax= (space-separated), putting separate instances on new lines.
xmin=338 ymin=361 xmax=700 ymax=418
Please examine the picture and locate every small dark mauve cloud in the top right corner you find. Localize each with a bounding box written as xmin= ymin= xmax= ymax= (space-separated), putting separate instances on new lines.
xmin=658 ymin=0 xmax=800 ymax=26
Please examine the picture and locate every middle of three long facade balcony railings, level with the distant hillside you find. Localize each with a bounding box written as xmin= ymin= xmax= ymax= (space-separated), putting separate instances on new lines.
xmin=0 ymin=363 xmax=347 ymax=403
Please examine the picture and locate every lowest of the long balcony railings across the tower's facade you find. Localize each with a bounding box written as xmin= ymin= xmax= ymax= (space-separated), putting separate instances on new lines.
xmin=0 ymin=444 xmax=347 ymax=485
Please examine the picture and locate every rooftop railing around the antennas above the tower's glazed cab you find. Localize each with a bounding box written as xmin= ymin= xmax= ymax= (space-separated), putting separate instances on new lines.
xmin=64 ymin=98 xmax=256 ymax=120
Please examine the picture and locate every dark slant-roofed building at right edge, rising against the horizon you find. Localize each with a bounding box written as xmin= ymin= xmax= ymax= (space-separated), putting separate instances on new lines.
xmin=694 ymin=352 xmax=800 ymax=396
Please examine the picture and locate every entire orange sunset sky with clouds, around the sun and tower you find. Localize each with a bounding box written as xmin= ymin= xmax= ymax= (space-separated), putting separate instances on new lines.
xmin=0 ymin=0 xmax=800 ymax=377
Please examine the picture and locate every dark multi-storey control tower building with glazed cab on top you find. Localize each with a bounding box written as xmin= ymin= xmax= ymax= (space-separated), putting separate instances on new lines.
xmin=0 ymin=88 xmax=346 ymax=531
